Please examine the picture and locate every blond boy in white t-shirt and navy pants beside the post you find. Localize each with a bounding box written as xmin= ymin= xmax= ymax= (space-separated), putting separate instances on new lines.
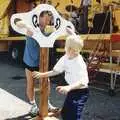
xmin=33 ymin=28 xmax=89 ymax=120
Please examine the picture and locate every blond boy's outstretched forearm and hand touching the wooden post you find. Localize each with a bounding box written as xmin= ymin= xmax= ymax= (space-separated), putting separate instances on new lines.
xmin=32 ymin=70 xmax=59 ymax=79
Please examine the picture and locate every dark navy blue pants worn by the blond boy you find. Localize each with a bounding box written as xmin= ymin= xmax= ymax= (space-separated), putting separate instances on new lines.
xmin=61 ymin=88 xmax=89 ymax=120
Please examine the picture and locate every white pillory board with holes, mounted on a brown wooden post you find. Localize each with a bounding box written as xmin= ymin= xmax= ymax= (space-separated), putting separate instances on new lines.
xmin=11 ymin=0 xmax=74 ymax=120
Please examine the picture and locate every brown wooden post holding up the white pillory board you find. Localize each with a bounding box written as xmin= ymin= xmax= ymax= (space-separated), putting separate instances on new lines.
xmin=37 ymin=48 xmax=49 ymax=120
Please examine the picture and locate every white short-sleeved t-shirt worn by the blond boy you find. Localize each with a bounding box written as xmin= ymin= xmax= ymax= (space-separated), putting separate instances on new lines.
xmin=53 ymin=54 xmax=89 ymax=87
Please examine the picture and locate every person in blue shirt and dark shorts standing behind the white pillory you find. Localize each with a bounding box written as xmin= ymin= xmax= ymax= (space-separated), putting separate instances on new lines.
xmin=16 ymin=3 xmax=58 ymax=116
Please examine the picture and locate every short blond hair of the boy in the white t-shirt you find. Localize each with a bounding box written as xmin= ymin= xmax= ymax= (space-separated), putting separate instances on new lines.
xmin=65 ymin=35 xmax=84 ymax=53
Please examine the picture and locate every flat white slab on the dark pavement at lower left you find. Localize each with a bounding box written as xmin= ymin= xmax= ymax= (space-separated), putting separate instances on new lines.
xmin=0 ymin=88 xmax=30 ymax=120
